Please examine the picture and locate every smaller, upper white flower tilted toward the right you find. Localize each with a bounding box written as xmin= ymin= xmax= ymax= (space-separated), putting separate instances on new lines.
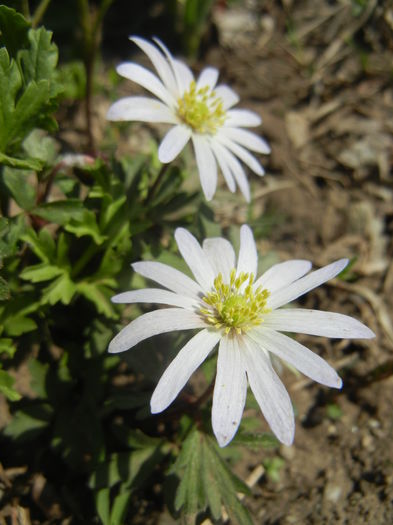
xmin=107 ymin=37 xmax=270 ymax=201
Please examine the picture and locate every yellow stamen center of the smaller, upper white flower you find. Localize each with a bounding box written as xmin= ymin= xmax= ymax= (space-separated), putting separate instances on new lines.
xmin=177 ymin=81 xmax=225 ymax=135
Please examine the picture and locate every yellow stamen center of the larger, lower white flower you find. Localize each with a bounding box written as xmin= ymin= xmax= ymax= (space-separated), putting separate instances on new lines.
xmin=200 ymin=269 xmax=270 ymax=334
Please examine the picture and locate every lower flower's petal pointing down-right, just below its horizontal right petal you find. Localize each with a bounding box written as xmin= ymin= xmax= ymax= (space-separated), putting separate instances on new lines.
xmin=248 ymin=326 xmax=342 ymax=388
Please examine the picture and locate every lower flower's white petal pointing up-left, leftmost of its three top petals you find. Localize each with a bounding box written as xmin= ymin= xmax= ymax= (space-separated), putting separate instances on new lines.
xmin=175 ymin=228 xmax=215 ymax=291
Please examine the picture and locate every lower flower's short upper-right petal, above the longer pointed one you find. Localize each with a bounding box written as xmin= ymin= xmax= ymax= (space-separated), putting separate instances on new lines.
xmin=254 ymin=259 xmax=312 ymax=293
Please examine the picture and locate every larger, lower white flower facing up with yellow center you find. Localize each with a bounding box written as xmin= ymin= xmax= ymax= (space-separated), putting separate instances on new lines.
xmin=109 ymin=226 xmax=374 ymax=446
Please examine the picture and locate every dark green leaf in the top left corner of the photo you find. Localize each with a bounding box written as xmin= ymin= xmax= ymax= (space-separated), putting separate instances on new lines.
xmin=0 ymin=5 xmax=30 ymax=58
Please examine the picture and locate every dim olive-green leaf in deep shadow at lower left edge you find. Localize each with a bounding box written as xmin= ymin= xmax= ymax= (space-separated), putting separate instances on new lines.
xmin=4 ymin=404 xmax=53 ymax=441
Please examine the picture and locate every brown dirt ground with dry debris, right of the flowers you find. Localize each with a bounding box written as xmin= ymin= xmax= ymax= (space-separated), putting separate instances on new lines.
xmin=0 ymin=0 xmax=393 ymax=525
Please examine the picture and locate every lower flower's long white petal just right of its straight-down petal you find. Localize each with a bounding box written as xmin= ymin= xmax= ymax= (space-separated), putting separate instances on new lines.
xmin=243 ymin=336 xmax=295 ymax=445
